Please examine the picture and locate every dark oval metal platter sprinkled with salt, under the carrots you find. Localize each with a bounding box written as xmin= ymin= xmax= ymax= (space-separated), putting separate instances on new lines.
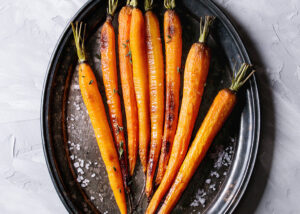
xmin=41 ymin=0 xmax=260 ymax=213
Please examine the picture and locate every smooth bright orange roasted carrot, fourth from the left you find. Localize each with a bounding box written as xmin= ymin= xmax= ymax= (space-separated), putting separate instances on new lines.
xmin=129 ymin=0 xmax=150 ymax=173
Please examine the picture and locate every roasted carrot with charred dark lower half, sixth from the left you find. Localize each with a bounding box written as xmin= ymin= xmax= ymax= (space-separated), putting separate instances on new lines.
xmin=155 ymin=0 xmax=182 ymax=185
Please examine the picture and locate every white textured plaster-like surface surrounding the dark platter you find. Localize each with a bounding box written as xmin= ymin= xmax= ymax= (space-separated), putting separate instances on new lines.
xmin=0 ymin=0 xmax=300 ymax=214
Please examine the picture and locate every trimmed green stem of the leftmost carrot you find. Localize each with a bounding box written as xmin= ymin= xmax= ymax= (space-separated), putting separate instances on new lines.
xmin=71 ymin=22 xmax=86 ymax=62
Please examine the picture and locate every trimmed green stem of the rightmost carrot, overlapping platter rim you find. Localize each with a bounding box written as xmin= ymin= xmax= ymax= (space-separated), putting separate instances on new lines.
xmin=229 ymin=63 xmax=255 ymax=92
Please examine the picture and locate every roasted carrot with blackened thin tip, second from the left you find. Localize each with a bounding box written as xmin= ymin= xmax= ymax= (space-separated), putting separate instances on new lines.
xmin=100 ymin=0 xmax=130 ymax=197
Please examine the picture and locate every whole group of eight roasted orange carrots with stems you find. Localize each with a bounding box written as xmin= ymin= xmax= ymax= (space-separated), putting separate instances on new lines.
xmin=72 ymin=0 xmax=254 ymax=214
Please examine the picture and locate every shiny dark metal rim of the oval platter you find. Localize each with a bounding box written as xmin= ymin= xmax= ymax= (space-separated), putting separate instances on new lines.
xmin=40 ymin=0 xmax=261 ymax=213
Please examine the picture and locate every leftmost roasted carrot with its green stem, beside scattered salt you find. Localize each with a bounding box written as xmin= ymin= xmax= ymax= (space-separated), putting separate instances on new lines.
xmin=72 ymin=23 xmax=127 ymax=214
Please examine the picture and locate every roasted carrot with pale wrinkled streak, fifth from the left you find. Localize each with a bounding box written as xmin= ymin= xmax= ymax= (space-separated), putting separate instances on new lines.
xmin=145 ymin=0 xmax=164 ymax=198
